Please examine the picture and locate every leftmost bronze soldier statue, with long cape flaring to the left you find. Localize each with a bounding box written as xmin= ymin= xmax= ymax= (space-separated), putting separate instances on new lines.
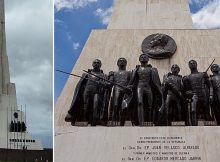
xmin=65 ymin=59 xmax=108 ymax=126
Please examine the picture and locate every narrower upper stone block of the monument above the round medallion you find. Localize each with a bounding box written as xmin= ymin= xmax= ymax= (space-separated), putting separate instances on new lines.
xmin=108 ymin=0 xmax=193 ymax=29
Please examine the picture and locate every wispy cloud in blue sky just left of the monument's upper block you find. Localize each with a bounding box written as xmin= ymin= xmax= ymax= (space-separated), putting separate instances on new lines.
xmin=95 ymin=7 xmax=113 ymax=25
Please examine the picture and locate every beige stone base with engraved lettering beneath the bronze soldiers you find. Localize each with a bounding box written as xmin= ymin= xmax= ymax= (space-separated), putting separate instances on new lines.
xmin=54 ymin=126 xmax=220 ymax=162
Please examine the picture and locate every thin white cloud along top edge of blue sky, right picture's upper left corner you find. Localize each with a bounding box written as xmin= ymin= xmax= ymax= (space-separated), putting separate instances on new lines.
xmin=55 ymin=0 xmax=98 ymax=11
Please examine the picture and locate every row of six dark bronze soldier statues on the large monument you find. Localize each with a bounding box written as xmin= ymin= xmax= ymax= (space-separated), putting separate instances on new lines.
xmin=65 ymin=54 xmax=220 ymax=126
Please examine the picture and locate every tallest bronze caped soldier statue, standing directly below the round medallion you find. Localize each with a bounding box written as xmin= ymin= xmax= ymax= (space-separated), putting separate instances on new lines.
xmin=125 ymin=54 xmax=162 ymax=126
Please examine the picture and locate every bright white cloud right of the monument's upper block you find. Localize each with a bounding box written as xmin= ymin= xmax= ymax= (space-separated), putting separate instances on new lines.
xmin=192 ymin=0 xmax=220 ymax=29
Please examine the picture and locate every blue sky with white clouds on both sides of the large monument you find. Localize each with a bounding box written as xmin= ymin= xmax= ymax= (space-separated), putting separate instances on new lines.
xmin=54 ymin=0 xmax=220 ymax=102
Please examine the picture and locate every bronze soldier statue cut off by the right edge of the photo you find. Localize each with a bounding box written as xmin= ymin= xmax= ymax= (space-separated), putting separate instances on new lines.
xmin=210 ymin=64 xmax=220 ymax=125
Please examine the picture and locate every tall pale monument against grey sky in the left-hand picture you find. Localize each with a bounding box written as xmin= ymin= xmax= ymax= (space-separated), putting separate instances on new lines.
xmin=0 ymin=0 xmax=43 ymax=150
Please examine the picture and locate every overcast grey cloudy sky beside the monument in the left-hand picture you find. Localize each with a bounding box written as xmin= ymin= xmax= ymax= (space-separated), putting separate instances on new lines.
xmin=5 ymin=0 xmax=53 ymax=147
